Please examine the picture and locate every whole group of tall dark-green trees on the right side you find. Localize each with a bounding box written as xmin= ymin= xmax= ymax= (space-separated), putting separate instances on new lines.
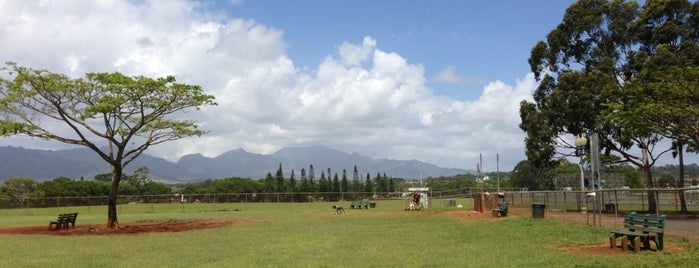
xmin=524 ymin=0 xmax=699 ymax=214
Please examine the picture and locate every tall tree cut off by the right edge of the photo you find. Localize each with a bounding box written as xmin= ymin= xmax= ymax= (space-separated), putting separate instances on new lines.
xmin=609 ymin=0 xmax=699 ymax=212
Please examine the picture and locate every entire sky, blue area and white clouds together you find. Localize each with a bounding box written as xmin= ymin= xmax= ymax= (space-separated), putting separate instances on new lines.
xmin=0 ymin=0 xmax=592 ymax=171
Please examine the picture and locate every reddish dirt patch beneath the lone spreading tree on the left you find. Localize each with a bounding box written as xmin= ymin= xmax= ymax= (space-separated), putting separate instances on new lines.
xmin=0 ymin=219 xmax=258 ymax=235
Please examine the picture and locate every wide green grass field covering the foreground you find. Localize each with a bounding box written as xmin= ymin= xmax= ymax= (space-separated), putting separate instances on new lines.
xmin=0 ymin=199 xmax=699 ymax=267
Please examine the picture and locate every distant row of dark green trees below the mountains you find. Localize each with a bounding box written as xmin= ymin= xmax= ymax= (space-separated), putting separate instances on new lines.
xmin=0 ymin=164 xmax=404 ymax=206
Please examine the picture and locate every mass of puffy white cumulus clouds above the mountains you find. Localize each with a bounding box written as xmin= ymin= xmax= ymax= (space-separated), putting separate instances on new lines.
xmin=0 ymin=1 xmax=535 ymax=169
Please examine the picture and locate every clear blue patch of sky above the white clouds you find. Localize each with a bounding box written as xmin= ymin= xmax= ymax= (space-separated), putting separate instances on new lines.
xmin=218 ymin=0 xmax=574 ymax=99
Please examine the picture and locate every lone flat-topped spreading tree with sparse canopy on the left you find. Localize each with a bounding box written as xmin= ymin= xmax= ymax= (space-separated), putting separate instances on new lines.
xmin=0 ymin=62 xmax=215 ymax=227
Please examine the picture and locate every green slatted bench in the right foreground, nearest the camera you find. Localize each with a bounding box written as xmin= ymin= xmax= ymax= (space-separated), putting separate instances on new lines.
xmin=609 ymin=212 xmax=666 ymax=252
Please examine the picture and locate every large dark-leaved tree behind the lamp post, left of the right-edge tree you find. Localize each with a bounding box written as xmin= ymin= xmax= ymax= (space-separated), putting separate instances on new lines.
xmin=520 ymin=0 xmax=692 ymax=210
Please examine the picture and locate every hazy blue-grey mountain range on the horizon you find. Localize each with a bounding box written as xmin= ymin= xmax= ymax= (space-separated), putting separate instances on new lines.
xmin=0 ymin=146 xmax=472 ymax=182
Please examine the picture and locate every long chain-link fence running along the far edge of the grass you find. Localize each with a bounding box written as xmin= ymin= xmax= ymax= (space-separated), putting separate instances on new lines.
xmin=0 ymin=187 xmax=699 ymax=213
